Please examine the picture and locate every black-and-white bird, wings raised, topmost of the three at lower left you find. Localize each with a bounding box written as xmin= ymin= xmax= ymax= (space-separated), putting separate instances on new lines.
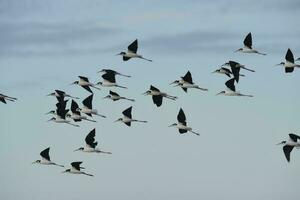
xmin=75 ymin=128 xmax=112 ymax=154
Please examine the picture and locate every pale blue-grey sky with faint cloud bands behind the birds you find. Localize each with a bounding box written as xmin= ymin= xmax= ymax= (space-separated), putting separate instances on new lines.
xmin=0 ymin=0 xmax=300 ymax=200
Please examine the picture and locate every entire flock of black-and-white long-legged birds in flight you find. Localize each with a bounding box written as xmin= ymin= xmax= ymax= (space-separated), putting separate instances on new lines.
xmin=0 ymin=33 xmax=300 ymax=176
